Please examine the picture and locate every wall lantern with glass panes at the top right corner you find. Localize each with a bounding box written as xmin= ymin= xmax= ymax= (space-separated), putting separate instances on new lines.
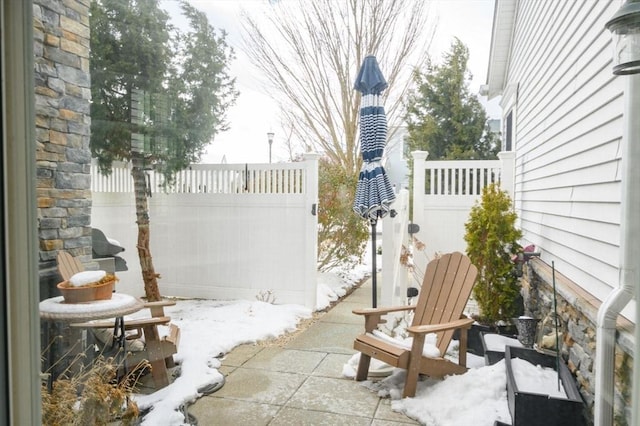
xmin=605 ymin=0 xmax=640 ymax=75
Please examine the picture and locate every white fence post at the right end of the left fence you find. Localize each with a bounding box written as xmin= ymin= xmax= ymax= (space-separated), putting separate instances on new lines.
xmin=303 ymin=152 xmax=320 ymax=310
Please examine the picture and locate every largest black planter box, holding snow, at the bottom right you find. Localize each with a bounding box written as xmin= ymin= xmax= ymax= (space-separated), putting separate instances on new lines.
xmin=505 ymin=346 xmax=586 ymax=426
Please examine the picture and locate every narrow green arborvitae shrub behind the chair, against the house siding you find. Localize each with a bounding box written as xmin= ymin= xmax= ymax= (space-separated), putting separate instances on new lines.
xmin=464 ymin=183 xmax=522 ymax=324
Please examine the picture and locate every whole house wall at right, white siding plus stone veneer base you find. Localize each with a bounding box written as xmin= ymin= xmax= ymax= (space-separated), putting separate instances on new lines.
xmin=489 ymin=0 xmax=635 ymax=425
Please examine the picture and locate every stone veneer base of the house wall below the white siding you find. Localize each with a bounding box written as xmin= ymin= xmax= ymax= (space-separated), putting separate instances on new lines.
xmin=522 ymin=259 xmax=634 ymax=426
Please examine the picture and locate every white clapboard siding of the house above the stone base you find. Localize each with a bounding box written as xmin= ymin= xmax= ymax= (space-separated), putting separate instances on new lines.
xmin=502 ymin=0 xmax=633 ymax=318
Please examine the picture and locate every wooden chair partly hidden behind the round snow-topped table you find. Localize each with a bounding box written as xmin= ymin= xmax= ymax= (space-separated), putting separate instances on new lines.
xmin=57 ymin=251 xmax=180 ymax=387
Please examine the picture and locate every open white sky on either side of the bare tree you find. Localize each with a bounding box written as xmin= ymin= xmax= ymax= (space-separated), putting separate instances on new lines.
xmin=169 ymin=0 xmax=500 ymax=164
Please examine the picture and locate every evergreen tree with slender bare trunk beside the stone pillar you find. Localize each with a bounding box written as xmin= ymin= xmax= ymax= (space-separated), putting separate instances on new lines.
xmin=89 ymin=0 xmax=237 ymax=301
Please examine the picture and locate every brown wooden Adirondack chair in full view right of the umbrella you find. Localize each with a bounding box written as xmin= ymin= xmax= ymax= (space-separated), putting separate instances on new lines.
xmin=353 ymin=252 xmax=478 ymax=397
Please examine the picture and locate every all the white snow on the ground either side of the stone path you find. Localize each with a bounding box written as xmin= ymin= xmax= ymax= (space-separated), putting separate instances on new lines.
xmin=124 ymin=260 xmax=520 ymax=426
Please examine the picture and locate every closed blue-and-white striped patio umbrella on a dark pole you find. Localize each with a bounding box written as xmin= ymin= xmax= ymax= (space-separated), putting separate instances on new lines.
xmin=353 ymin=56 xmax=396 ymax=308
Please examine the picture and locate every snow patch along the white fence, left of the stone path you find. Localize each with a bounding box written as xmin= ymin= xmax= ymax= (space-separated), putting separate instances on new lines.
xmin=132 ymin=300 xmax=311 ymax=426
